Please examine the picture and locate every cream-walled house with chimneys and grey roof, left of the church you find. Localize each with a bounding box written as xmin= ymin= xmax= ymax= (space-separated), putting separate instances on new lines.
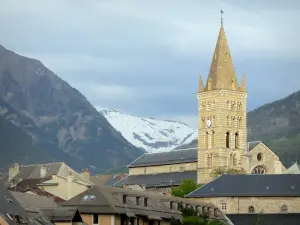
xmin=8 ymin=162 xmax=93 ymax=200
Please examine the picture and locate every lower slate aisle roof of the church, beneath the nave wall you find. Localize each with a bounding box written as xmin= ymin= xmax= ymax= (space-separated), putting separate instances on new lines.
xmin=113 ymin=170 xmax=197 ymax=187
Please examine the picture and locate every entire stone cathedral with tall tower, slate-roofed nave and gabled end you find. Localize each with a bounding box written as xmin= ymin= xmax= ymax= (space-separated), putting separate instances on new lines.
xmin=118 ymin=14 xmax=286 ymax=193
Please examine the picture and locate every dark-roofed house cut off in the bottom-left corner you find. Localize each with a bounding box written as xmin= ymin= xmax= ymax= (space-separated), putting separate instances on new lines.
xmin=0 ymin=179 xmax=53 ymax=225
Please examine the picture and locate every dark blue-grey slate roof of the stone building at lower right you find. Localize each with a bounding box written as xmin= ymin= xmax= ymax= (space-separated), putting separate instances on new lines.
xmin=187 ymin=174 xmax=300 ymax=198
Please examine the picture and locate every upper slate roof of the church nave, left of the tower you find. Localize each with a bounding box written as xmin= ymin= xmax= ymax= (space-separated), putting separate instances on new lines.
xmin=128 ymin=148 xmax=197 ymax=168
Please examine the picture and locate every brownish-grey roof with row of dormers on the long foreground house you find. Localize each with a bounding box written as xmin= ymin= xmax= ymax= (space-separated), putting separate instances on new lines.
xmin=62 ymin=186 xmax=224 ymax=220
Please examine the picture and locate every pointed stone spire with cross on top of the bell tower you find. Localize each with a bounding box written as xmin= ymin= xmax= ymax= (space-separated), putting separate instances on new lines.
xmin=206 ymin=10 xmax=239 ymax=90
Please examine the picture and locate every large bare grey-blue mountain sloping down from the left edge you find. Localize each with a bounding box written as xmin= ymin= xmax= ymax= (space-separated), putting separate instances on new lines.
xmin=0 ymin=45 xmax=144 ymax=172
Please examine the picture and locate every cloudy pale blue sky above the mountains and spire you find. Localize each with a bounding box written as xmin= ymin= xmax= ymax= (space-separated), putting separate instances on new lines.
xmin=0 ymin=0 xmax=300 ymax=128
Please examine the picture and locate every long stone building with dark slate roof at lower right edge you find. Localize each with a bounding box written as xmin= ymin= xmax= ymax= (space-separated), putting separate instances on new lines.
xmin=187 ymin=174 xmax=300 ymax=214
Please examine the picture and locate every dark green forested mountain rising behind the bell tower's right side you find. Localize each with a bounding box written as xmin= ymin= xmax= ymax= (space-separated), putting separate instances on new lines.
xmin=177 ymin=91 xmax=300 ymax=166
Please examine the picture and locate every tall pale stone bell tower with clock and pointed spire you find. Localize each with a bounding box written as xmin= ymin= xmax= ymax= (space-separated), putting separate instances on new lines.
xmin=197 ymin=11 xmax=247 ymax=184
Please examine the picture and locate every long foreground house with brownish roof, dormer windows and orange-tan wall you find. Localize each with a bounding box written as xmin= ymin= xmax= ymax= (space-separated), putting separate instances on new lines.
xmin=61 ymin=186 xmax=230 ymax=225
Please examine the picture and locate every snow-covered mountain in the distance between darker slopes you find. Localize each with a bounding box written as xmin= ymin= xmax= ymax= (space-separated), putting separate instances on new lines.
xmin=100 ymin=109 xmax=197 ymax=152
